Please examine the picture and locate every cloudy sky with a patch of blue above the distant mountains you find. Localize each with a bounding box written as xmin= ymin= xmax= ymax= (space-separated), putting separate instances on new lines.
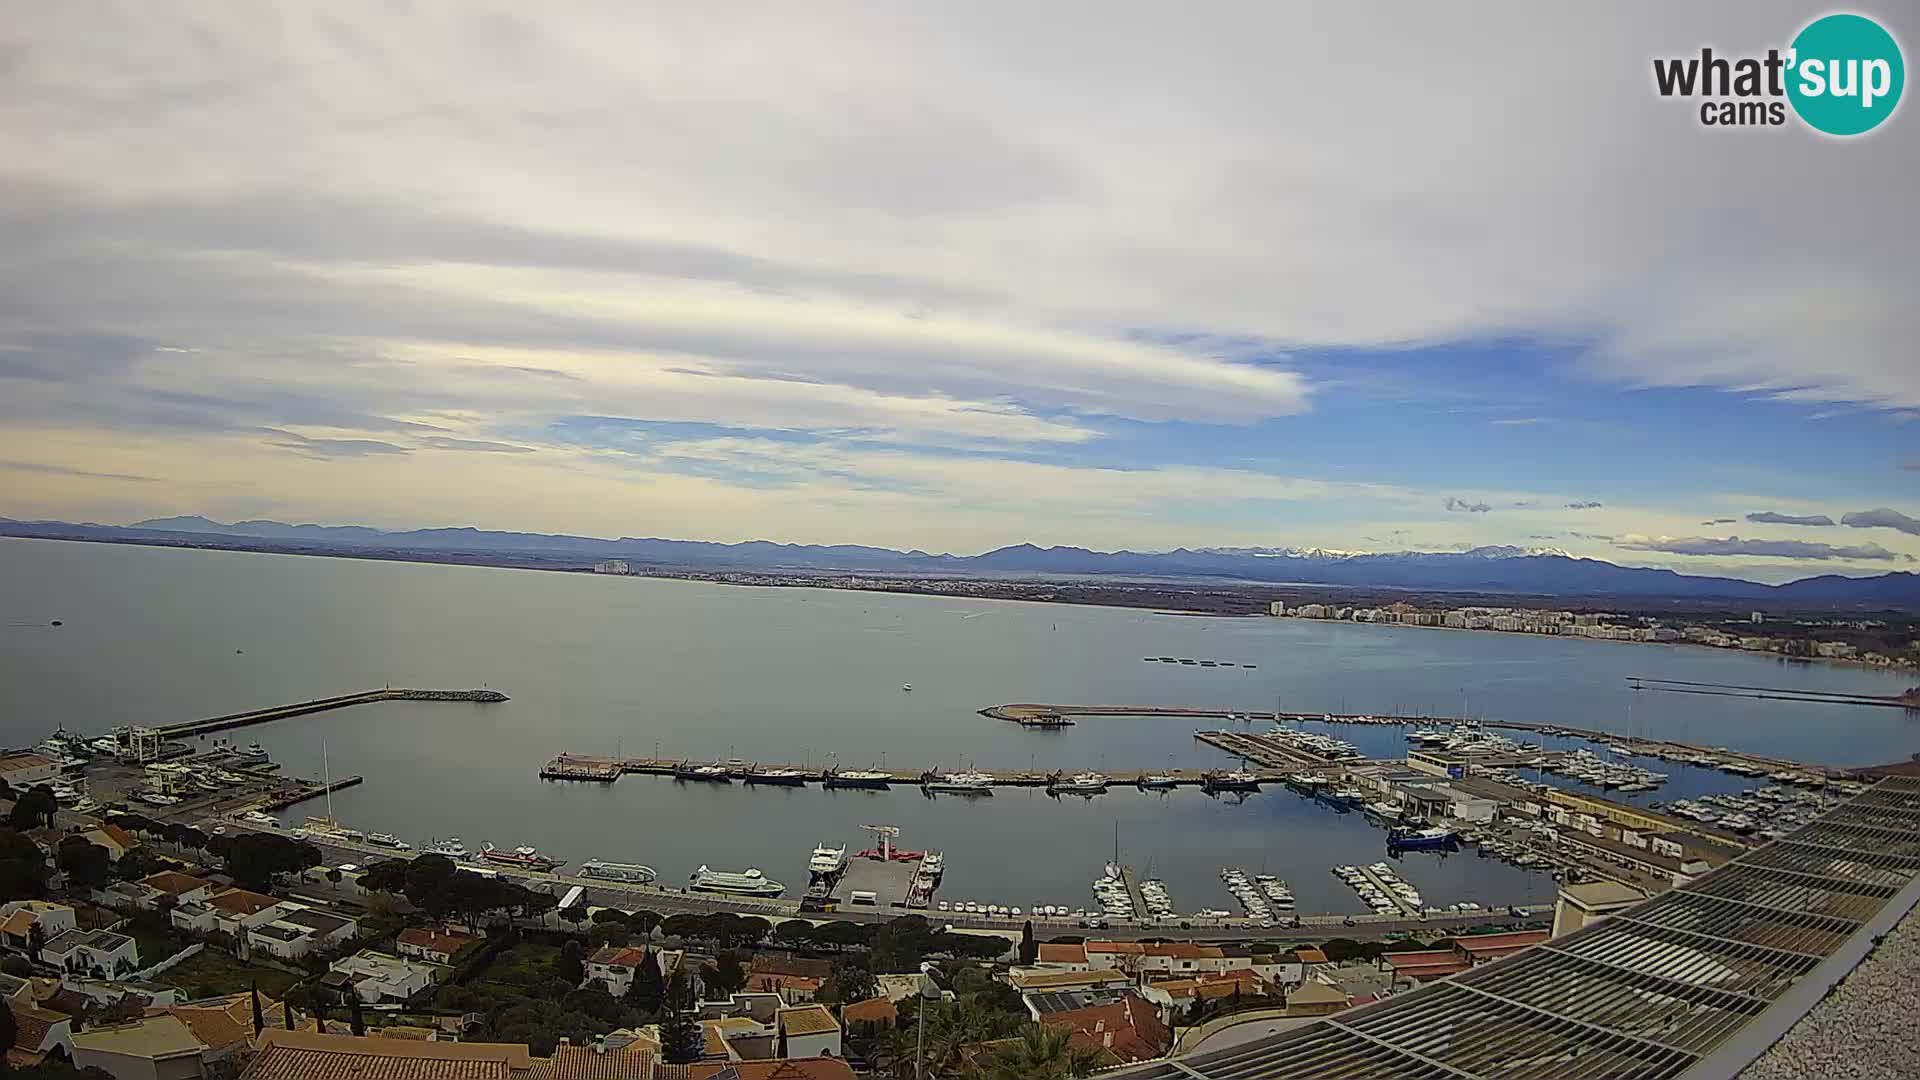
xmin=0 ymin=0 xmax=1920 ymax=580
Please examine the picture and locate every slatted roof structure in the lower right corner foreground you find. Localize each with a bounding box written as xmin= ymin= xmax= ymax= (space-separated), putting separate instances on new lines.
xmin=1123 ymin=778 xmax=1920 ymax=1080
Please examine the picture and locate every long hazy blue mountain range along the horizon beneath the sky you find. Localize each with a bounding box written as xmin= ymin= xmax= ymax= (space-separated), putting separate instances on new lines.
xmin=0 ymin=517 xmax=1920 ymax=611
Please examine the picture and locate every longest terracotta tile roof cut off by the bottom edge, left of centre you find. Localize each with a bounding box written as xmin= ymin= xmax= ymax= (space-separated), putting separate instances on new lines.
xmin=240 ymin=1028 xmax=534 ymax=1080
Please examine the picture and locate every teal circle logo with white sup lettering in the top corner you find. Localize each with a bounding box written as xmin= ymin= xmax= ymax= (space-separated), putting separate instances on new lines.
xmin=1788 ymin=15 xmax=1907 ymax=135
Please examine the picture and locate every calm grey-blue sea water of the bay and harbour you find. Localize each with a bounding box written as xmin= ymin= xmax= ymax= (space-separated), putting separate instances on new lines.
xmin=0 ymin=538 xmax=1920 ymax=911
